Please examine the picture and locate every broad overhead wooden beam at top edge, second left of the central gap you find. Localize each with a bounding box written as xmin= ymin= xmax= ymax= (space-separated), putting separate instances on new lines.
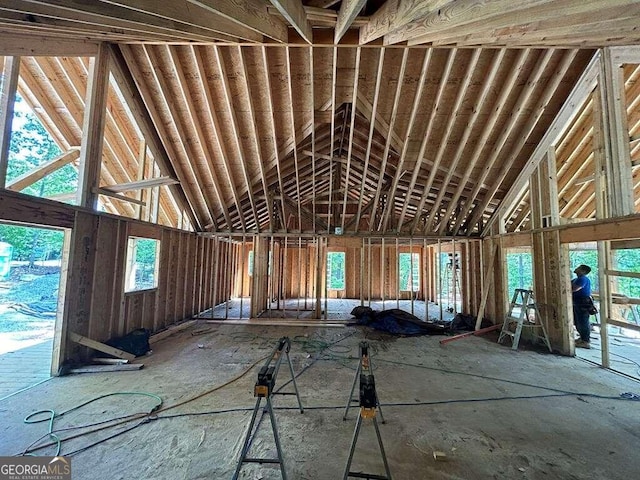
xmin=187 ymin=0 xmax=289 ymax=43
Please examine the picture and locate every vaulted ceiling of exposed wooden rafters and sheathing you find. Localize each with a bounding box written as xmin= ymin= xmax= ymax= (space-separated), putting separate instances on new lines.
xmin=0 ymin=0 xmax=640 ymax=235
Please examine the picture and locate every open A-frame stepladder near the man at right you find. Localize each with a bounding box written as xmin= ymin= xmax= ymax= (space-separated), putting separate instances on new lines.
xmin=498 ymin=288 xmax=552 ymax=352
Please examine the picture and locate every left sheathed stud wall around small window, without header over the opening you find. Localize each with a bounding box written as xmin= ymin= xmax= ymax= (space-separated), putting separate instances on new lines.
xmin=64 ymin=212 xmax=214 ymax=359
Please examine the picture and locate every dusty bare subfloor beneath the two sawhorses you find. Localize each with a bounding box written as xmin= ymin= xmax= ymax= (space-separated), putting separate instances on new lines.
xmin=0 ymin=324 xmax=640 ymax=480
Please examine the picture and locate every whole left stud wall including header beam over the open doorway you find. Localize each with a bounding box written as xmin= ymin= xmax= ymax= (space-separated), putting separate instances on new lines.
xmin=0 ymin=191 xmax=216 ymax=374
